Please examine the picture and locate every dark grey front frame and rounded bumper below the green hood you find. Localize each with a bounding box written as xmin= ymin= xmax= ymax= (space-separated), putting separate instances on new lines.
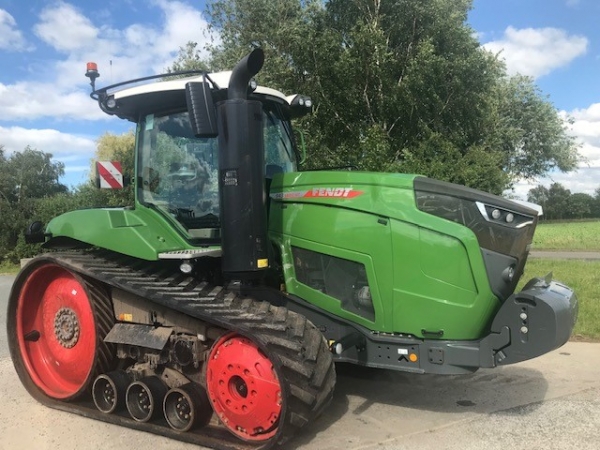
xmin=279 ymin=277 xmax=578 ymax=375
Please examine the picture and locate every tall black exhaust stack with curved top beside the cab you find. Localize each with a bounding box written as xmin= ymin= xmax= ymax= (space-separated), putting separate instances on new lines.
xmin=217 ymin=49 xmax=269 ymax=279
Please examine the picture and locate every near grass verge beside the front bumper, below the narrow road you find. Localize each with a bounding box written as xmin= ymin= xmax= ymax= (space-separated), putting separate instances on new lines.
xmin=517 ymin=258 xmax=600 ymax=341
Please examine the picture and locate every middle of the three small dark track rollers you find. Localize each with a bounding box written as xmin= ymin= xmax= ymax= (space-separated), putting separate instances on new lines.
xmin=125 ymin=376 xmax=169 ymax=422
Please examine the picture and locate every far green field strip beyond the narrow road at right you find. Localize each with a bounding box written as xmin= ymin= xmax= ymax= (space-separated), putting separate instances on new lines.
xmin=532 ymin=220 xmax=600 ymax=251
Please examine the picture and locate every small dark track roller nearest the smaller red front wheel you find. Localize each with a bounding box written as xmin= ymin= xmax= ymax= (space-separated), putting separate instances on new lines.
xmin=163 ymin=383 xmax=213 ymax=431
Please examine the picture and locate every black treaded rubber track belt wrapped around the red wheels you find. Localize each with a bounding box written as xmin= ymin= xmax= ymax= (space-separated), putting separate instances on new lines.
xmin=15 ymin=251 xmax=335 ymax=450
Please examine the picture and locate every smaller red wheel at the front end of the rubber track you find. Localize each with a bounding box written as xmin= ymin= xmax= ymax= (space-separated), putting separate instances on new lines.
xmin=206 ymin=334 xmax=282 ymax=441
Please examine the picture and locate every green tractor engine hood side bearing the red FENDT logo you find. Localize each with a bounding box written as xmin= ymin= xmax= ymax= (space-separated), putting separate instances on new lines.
xmin=269 ymin=172 xmax=500 ymax=340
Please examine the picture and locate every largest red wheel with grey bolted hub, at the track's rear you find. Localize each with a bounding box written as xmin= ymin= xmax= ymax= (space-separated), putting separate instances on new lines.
xmin=11 ymin=264 xmax=104 ymax=400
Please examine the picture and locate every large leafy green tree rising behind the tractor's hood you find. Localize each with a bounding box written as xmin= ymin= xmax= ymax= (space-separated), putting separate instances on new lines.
xmin=203 ymin=0 xmax=578 ymax=193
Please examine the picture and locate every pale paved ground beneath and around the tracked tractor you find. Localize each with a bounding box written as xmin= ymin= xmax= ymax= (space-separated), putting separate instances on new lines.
xmin=0 ymin=276 xmax=600 ymax=450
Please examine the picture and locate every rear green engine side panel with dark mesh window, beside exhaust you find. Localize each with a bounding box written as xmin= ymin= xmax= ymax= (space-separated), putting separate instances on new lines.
xmin=270 ymin=203 xmax=393 ymax=331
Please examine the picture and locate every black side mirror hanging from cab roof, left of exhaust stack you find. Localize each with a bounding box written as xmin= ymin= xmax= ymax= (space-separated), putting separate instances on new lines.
xmin=185 ymin=81 xmax=219 ymax=138
